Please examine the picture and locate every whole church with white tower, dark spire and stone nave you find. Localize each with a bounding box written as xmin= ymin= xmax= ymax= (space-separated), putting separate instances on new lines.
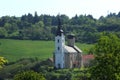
xmin=54 ymin=18 xmax=83 ymax=69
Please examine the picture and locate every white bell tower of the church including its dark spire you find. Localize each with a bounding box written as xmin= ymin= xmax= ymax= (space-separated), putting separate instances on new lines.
xmin=54 ymin=16 xmax=65 ymax=69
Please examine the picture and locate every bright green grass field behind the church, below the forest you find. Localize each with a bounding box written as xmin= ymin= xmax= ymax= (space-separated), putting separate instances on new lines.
xmin=0 ymin=39 xmax=93 ymax=62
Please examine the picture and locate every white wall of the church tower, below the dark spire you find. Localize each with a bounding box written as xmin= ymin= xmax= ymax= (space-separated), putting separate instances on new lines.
xmin=55 ymin=35 xmax=65 ymax=68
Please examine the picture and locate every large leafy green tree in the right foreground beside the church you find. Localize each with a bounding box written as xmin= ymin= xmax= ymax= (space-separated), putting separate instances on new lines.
xmin=90 ymin=34 xmax=120 ymax=80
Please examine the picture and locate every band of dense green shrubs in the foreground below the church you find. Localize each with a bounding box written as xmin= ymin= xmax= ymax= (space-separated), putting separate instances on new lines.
xmin=0 ymin=58 xmax=89 ymax=80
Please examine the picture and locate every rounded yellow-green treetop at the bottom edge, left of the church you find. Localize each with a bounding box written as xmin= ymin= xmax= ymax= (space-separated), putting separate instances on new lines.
xmin=14 ymin=71 xmax=46 ymax=80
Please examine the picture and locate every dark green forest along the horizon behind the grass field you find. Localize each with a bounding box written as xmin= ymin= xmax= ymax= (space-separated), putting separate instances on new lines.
xmin=0 ymin=12 xmax=120 ymax=43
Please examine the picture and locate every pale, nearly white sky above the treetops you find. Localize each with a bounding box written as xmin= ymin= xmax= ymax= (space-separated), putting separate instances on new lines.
xmin=0 ymin=0 xmax=120 ymax=18
